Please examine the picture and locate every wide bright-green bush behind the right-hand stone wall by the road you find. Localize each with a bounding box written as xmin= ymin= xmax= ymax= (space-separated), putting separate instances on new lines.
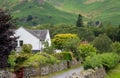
xmin=84 ymin=53 xmax=119 ymax=70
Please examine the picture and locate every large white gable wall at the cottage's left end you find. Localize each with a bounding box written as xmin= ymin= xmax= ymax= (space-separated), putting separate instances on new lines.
xmin=15 ymin=27 xmax=41 ymax=50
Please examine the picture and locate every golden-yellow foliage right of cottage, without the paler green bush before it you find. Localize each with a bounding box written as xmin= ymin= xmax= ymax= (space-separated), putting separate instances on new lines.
xmin=52 ymin=34 xmax=79 ymax=49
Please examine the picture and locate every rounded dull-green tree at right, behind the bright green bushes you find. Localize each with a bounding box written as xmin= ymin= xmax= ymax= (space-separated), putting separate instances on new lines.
xmin=93 ymin=34 xmax=112 ymax=52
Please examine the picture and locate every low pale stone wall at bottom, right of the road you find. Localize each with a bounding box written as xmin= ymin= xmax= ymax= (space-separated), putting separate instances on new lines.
xmin=66 ymin=68 xmax=106 ymax=78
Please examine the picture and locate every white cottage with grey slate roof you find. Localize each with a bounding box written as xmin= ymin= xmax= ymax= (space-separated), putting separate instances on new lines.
xmin=15 ymin=27 xmax=51 ymax=52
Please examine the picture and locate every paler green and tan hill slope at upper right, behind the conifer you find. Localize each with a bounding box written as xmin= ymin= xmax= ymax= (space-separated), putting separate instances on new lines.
xmin=47 ymin=0 xmax=120 ymax=25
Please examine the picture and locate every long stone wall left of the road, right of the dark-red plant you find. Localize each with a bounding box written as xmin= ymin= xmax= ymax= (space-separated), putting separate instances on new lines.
xmin=24 ymin=60 xmax=79 ymax=78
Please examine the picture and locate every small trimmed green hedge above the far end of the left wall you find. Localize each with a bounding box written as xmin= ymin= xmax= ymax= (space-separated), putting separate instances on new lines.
xmin=53 ymin=52 xmax=73 ymax=61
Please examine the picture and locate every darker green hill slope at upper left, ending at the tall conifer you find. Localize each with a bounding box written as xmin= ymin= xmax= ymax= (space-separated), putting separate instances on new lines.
xmin=0 ymin=0 xmax=77 ymax=26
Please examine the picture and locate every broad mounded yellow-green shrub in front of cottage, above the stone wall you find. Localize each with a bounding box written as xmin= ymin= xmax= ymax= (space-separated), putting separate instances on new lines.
xmin=23 ymin=53 xmax=57 ymax=67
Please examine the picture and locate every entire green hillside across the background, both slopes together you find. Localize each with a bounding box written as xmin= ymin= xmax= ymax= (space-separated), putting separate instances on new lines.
xmin=0 ymin=0 xmax=120 ymax=26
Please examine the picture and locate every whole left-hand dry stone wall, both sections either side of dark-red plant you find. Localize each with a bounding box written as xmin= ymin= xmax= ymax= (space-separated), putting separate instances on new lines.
xmin=0 ymin=60 xmax=80 ymax=78
